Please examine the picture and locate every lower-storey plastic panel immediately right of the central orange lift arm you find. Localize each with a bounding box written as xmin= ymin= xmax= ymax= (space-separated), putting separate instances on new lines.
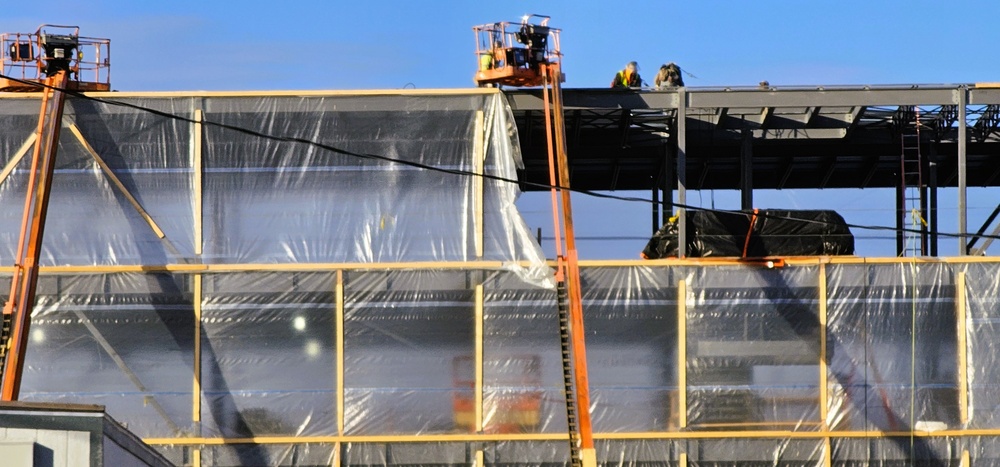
xmin=581 ymin=267 xmax=683 ymax=432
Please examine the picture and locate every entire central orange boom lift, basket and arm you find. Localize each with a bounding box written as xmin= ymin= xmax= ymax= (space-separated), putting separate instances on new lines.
xmin=473 ymin=15 xmax=597 ymax=467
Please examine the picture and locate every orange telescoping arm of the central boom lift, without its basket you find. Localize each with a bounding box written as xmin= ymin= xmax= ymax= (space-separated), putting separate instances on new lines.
xmin=547 ymin=63 xmax=594 ymax=462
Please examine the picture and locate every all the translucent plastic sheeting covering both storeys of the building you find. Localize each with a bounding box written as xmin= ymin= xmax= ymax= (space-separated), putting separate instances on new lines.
xmin=0 ymin=93 xmax=1000 ymax=466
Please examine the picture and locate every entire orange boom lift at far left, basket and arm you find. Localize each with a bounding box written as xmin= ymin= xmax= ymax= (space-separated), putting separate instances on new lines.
xmin=0 ymin=24 xmax=111 ymax=401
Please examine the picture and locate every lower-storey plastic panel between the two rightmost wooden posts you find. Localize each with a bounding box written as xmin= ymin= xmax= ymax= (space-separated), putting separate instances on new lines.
xmin=827 ymin=264 xmax=960 ymax=431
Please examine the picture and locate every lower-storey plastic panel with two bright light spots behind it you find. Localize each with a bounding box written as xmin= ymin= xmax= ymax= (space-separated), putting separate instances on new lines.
xmin=200 ymin=272 xmax=337 ymax=438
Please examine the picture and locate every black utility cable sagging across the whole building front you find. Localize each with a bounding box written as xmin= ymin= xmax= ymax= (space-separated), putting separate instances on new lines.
xmin=0 ymin=74 xmax=1000 ymax=245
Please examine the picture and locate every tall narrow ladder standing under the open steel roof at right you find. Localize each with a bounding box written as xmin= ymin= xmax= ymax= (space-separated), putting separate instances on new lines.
xmin=898 ymin=106 xmax=927 ymax=256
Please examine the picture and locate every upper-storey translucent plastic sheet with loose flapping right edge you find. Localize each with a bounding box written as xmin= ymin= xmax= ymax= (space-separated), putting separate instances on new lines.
xmin=0 ymin=93 xmax=544 ymax=272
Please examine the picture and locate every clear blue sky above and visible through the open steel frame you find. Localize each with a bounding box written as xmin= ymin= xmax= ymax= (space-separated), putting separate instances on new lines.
xmin=0 ymin=0 xmax=1000 ymax=257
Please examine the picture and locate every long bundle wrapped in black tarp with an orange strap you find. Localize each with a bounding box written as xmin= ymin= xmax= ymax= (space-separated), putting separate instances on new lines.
xmin=642 ymin=209 xmax=854 ymax=259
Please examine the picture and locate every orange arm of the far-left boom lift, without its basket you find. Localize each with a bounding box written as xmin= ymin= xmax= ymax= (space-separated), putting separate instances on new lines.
xmin=0 ymin=71 xmax=68 ymax=401
